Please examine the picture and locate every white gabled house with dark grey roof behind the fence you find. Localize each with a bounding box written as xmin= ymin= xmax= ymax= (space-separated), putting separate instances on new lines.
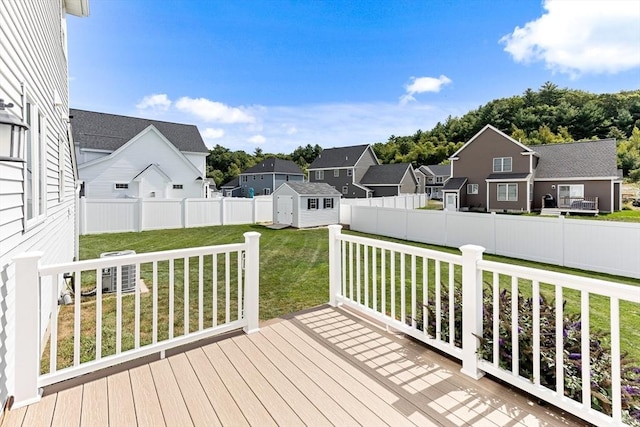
xmin=71 ymin=109 xmax=210 ymax=199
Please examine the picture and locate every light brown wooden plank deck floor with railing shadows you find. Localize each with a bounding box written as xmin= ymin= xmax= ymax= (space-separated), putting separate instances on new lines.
xmin=4 ymin=307 xmax=579 ymax=427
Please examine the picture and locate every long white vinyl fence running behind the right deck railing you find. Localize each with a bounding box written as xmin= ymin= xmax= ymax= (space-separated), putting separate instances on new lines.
xmin=350 ymin=206 xmax=640 ymax=278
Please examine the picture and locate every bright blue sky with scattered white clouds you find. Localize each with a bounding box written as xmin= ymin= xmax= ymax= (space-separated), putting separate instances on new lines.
xmin=67 ymin=0 xmax=640 ymax=153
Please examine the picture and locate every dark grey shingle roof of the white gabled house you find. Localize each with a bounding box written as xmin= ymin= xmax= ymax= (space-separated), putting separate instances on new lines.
xmin=69 ymin=109 xmax=209 ymax=153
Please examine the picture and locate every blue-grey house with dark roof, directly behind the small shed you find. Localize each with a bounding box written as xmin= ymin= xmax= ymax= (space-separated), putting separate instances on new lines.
xmin=234 ymin=157 xmax=304 ymax=197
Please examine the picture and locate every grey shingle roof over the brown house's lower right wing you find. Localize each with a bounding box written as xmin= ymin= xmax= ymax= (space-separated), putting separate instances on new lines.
xmin=529 ymin=139 xmax=618 ymax=179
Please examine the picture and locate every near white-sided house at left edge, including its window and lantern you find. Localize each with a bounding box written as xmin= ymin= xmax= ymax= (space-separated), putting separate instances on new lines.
xmin=0 ymin=0 xmax=89 ymax=409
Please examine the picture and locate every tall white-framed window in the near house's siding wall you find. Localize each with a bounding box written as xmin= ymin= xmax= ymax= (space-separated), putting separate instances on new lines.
xmin=24 ymin=101 xmax=47 ymax=222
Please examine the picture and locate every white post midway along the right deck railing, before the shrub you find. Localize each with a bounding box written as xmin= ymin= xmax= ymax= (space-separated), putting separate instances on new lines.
xmin=460 ymin=245 xmax=485 ymax=380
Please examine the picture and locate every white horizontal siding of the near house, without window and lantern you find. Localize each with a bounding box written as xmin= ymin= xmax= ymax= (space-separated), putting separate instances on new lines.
xmin=0 ymin=1 xmax=76 ymax=412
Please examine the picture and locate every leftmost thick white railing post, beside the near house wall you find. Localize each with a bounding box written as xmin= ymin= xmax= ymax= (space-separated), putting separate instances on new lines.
xmin=13 ymin=252 xmax=44 ymax=408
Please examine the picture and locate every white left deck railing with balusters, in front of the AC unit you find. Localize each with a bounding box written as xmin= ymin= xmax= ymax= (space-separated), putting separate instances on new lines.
xmin=14 ymin=232 xmax=260 ymax=407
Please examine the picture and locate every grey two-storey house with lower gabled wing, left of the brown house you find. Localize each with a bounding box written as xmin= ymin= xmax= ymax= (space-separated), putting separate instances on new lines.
xmin=309 ymin=145 xmax=418 ymax=198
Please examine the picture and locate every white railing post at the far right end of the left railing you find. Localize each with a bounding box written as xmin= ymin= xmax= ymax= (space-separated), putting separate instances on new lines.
xmin=243 ymin=231 xmax=260 ymax=334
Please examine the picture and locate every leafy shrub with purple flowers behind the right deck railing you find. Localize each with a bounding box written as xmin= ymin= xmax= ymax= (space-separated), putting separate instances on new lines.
xmin=416 ymin=289 xmax=640 ymax=426
